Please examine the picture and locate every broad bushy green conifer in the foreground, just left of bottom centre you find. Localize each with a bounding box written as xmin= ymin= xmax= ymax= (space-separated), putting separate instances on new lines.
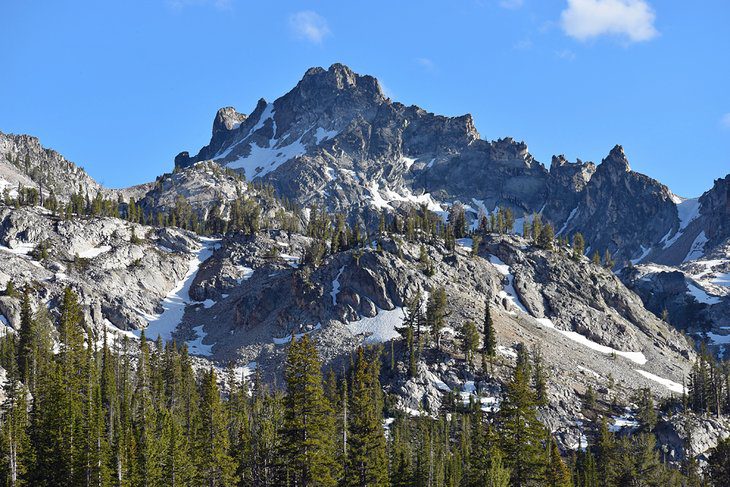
xmin=284 ymin=335 xmax=338 ymax=486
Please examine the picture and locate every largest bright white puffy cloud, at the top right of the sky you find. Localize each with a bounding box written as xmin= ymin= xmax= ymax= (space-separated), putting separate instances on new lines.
xmin=560 ymin=0 xmax=659 ymax=42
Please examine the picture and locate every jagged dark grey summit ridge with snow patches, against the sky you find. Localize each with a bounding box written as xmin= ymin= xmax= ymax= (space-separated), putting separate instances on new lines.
xmin=175 ymin=64 xmax=708 ymax=266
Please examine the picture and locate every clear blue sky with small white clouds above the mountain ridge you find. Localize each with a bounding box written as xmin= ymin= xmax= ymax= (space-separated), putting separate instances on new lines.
xmin=0 ymin=0 xmax=730 ymax=196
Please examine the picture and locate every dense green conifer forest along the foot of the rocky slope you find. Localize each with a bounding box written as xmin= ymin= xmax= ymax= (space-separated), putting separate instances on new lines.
xmin=0 ymin=276 xmax=730 ymax=487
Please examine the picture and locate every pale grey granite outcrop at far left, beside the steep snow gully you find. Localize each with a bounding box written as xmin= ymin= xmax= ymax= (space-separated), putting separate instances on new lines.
xmin=0 ymin=204 xmax=198 ymax=330
